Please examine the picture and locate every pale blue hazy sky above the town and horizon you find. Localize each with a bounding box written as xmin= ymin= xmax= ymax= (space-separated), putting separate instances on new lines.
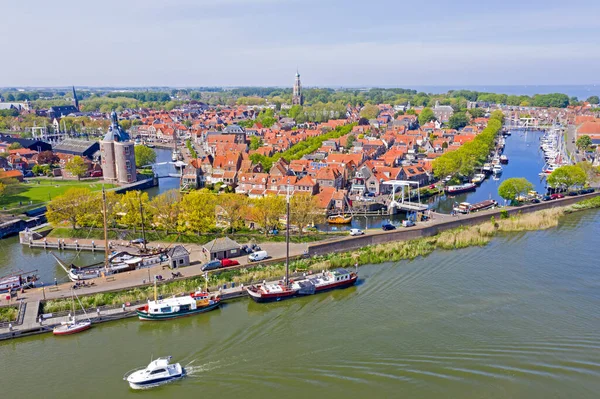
xmin=0 ymin=0 xmax=600 ymax=87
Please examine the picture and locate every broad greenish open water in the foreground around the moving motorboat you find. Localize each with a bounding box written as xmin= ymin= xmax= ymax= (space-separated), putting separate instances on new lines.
xmin=0 ymin=211 xmax=600 ymax=399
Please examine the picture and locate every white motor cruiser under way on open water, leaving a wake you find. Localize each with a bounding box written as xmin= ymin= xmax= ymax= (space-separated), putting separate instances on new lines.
xmin=123 ymin=356 xmax=185 ymax=389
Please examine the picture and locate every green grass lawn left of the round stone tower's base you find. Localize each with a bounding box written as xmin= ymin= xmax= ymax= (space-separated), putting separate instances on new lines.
xmin=0 ymin=179 xmax=115 ymax=209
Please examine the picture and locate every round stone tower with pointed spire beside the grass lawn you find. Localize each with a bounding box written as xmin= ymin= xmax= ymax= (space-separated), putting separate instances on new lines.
xmin=100 ymin=111 xmax=137 ymax=184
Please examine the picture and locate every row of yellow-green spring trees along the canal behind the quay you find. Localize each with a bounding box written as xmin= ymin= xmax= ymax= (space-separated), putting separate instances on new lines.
xmin=46 ymin=188 xmax=324 ymax=234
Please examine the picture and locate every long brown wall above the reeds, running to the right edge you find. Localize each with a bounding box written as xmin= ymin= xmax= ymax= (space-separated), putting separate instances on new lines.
xmin=308 ymin=192 xmax=600 ymax=256
